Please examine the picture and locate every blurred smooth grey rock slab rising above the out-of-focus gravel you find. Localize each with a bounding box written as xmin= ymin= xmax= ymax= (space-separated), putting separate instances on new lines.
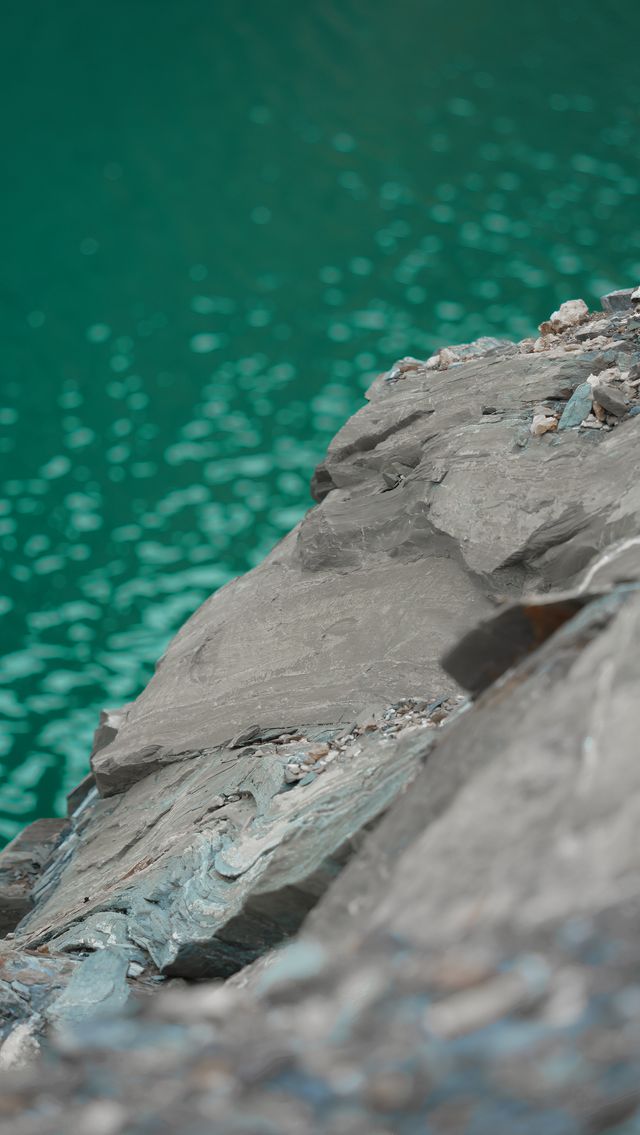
xmin=309 ymin=590 xmax=640 ymax=962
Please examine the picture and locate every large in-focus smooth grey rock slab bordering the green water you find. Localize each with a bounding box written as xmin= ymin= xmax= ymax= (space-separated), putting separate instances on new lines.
xmin=93 ymin=353 xmax=632 ymax=795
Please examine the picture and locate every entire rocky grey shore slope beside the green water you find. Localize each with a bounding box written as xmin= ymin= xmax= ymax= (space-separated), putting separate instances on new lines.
xmin=0 ymin=288 xmax=640 ymax=1135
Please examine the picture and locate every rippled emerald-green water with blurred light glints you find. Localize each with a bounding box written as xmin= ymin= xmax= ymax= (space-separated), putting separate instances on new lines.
xmin=0 ymin=0 xmax=640 ymax=839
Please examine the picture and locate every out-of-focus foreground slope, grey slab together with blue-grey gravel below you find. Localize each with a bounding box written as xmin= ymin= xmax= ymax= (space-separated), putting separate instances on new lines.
xmin=0 ymin=583 xmax=640 ymax=1135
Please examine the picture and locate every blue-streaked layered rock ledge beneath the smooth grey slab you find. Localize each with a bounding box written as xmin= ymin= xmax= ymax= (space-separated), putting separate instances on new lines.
xmin=17 ymin=728 xmax=431 ymax=977
